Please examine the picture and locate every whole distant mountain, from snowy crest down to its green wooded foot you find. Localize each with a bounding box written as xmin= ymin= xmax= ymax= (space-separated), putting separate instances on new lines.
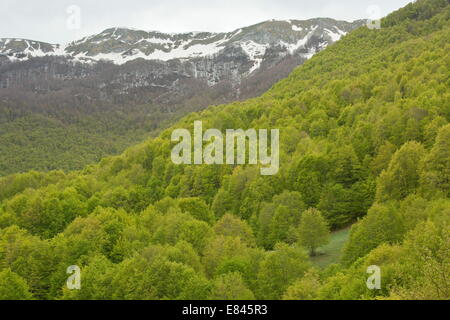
xmin=0 ymin=19 xmax=364 ymax=175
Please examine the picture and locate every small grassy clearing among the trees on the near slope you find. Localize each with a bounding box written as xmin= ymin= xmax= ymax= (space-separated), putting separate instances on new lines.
xmin=311 ymin=227 xmax=350 ymax=268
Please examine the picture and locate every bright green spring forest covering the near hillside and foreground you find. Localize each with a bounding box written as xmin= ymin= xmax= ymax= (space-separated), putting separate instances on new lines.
xmin=0 ymin=0 xmax=450 ymax=300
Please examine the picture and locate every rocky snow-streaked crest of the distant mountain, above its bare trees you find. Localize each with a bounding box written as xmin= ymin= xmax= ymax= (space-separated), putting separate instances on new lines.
xmin=0 ymin=18 xmax=364 ymax=71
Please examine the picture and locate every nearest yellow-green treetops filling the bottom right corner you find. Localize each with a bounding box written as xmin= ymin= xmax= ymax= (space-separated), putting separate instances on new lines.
xmin=319 ymin=215 xmax=450 ymax=300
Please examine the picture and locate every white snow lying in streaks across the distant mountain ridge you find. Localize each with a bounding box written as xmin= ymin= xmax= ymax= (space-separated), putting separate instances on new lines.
xmin=0 ymin=20 xmax=346 ymax=66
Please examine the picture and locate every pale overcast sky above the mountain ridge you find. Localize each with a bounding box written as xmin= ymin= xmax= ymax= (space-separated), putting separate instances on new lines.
xmin=0 ymin=0 xmax=411 ymax=43
